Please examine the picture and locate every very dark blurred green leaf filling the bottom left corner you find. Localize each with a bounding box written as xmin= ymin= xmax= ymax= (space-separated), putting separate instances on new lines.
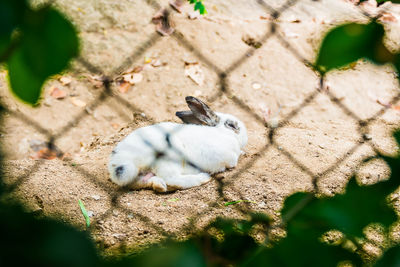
xmin=0 ymin=203 xmax=100 ymax=267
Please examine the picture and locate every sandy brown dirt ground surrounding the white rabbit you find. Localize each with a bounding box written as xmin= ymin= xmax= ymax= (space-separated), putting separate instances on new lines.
xmin=0 ymin=0 xmax=400 ymax=258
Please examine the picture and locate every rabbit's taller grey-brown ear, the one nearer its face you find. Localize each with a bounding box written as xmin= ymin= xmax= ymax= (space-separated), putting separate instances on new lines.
xmin=185 ymin=96 xmax=220 ymax=126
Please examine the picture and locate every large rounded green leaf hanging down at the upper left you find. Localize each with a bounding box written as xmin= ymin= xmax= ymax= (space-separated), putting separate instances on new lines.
xmin=7 ymin=7 xmax=78 ymax=105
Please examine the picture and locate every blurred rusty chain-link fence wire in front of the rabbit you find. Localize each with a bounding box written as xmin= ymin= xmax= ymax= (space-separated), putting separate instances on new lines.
xmin=1 ymin=0 xmax=400 ymax=255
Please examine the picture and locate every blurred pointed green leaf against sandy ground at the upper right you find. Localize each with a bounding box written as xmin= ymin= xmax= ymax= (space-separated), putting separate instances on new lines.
xmin=315 ymin=22 xmax=393 ymax=73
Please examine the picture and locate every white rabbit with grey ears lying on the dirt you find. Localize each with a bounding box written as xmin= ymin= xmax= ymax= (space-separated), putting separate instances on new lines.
xmin=108 ymin=96 xmax=247 ymax=192
